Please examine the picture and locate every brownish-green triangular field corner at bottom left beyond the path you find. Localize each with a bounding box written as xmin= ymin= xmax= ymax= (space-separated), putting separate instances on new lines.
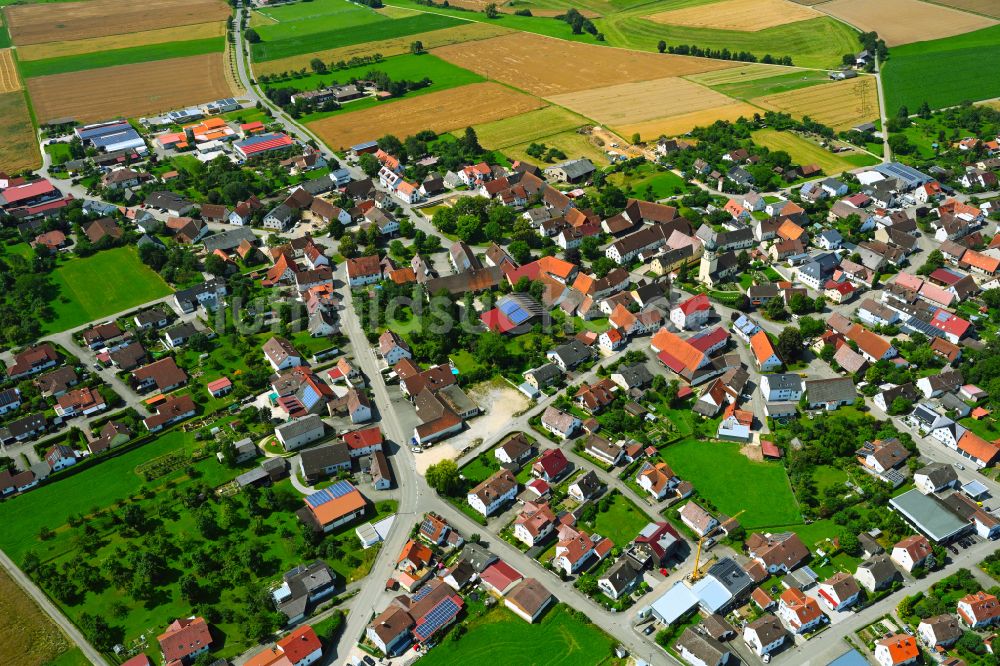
xmin=0 ymin=571 xmax=79 ymax=666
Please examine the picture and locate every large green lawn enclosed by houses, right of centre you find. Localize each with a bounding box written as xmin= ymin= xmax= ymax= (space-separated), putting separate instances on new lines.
xmin=660 ymin=439 xmax=802 ymax=529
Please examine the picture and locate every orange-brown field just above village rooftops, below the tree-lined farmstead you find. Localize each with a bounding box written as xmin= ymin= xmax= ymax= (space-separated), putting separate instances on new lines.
xmin=309 ymin=83 xmax=545 ymax=149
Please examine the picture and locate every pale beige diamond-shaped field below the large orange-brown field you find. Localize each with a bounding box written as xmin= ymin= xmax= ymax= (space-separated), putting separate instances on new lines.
xmin=547 ymin=76 xmax=733 ymax=128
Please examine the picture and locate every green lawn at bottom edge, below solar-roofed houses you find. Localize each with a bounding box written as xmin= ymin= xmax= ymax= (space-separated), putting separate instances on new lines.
xmin=421 ymin=604 xmax=616 ymax=666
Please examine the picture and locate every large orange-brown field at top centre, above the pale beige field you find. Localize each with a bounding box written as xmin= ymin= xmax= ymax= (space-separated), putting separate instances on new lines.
xmin=434 ymin=32 xmax=736 ymax=97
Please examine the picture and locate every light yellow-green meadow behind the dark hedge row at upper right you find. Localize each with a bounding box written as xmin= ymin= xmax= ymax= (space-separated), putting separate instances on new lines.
xmin=595 ymin=13 xmax=858 ymax=67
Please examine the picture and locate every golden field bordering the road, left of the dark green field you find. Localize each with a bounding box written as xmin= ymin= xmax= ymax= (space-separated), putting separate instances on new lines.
xmin=750 ymin=76 xmax=879 ymax=130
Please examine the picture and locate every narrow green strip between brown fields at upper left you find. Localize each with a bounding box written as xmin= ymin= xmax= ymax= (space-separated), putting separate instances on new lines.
xmin=18 ymin=37 xmax=226 ymax=78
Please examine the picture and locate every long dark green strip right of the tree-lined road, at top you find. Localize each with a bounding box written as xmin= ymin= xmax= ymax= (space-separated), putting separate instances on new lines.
xmin=251 ymin=14 xmax=460 ymax=61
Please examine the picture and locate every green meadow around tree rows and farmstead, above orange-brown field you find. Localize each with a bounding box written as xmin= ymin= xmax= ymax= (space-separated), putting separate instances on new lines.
xmin=272 ymin=53 xmax=485 ymax=91
